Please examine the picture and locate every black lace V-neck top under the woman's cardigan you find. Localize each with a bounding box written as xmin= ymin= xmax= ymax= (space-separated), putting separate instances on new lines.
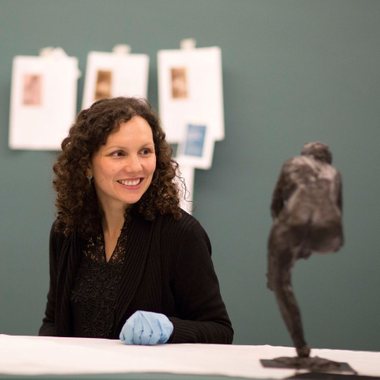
xmin=71 ymin=226 xmax=127 ymax=338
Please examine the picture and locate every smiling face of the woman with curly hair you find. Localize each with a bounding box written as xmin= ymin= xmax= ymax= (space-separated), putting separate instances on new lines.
xmin=89 ymin=116 xmax=156 ymax=212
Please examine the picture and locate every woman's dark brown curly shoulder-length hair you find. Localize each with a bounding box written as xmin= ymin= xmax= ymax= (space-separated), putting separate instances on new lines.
xmin=53 ymin=97 xmax=182 ymax=237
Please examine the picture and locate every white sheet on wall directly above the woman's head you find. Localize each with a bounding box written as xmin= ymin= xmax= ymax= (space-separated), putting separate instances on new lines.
xmin=82 ymin=51 xmax=149 ymax=108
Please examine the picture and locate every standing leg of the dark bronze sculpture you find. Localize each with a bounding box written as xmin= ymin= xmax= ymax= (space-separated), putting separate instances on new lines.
xmin=267 ymin=227 xmax=310 ymax=357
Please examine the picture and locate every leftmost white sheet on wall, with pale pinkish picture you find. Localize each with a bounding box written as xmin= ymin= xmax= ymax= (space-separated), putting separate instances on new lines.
xmin=9 ymin=48 xmax=80 ymax=150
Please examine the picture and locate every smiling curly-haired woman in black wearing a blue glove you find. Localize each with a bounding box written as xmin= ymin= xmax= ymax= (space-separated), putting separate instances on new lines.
xmin=40 ymin=97 xmax=233 ymax=345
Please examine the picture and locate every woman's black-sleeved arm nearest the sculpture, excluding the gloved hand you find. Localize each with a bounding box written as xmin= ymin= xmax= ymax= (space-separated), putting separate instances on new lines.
xmin=168 ymin=217 xmax=233 ymax=344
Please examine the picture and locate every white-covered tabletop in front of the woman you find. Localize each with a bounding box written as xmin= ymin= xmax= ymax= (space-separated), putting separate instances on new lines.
xmin=0 ymin=335 xmax=380 ymax=379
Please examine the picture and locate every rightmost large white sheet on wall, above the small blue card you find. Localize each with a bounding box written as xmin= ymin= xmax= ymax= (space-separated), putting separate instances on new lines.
xmin=158 ymin=47 xmax=224 ymax=143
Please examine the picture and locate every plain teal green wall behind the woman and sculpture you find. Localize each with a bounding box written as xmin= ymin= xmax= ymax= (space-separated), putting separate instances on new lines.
xmin=0 ymin=0 xmax=380 ymax=351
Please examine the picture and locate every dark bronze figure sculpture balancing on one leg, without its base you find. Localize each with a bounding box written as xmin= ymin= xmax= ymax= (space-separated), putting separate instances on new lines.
xmin=267 ymin=142 xmax=343 ymax=358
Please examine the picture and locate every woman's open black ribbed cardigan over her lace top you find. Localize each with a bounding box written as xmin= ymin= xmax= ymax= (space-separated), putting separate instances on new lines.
xmin=39 ymin=212 xmax=233 ymax=343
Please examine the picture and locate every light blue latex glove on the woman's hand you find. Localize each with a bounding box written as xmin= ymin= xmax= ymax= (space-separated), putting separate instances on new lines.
xmin=119 ymin=310 xmax=173 ymax=345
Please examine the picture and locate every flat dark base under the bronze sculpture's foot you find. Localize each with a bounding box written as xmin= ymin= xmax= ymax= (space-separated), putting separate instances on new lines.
xmin=260 ymin=356 xmax=356 ymax=374
